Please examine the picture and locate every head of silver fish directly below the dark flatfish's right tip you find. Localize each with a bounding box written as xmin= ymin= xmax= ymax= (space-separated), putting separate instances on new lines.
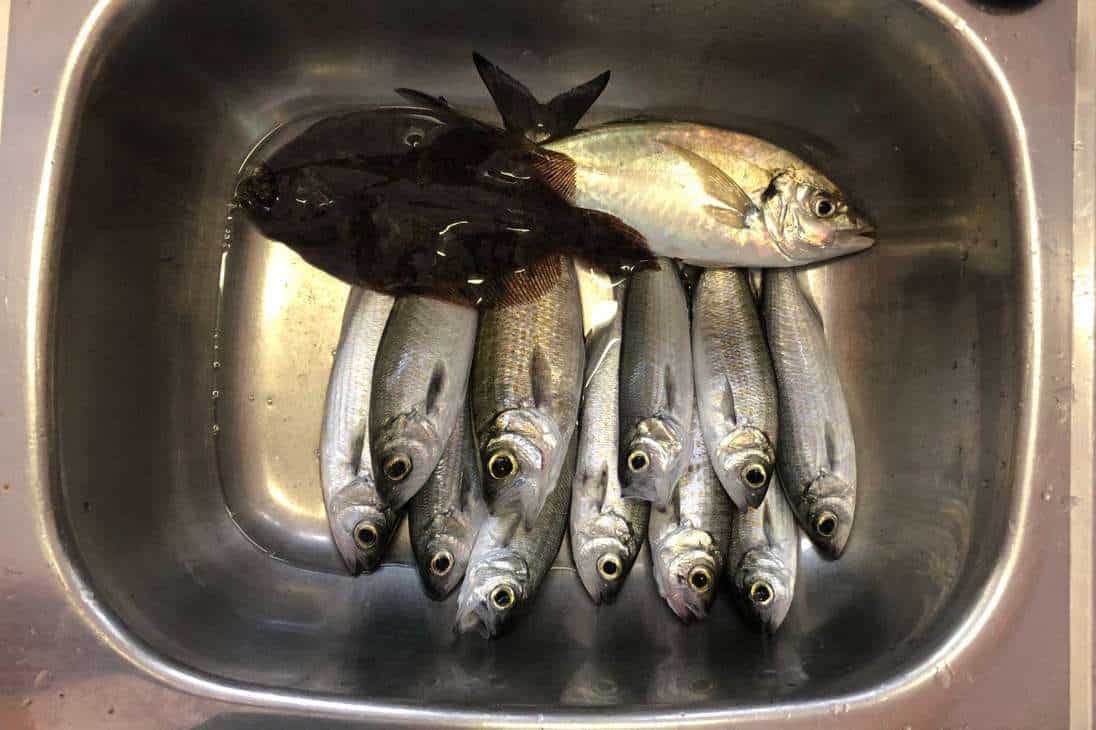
xmin=620 ymin=417 xmax=688 ymax=506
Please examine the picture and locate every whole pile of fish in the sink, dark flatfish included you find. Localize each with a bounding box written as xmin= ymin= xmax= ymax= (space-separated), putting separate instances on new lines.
xmin=237 ymin=55 xmax=874 ymax=636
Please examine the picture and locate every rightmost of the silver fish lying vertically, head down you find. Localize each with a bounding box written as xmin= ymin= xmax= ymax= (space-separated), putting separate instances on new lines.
xmin=762 ymin=270 xmax=856 ymax=558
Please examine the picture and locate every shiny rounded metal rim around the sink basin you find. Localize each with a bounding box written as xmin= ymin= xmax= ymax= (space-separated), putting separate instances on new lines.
xmin=24 ymin=0 xmax=1048 ymax=727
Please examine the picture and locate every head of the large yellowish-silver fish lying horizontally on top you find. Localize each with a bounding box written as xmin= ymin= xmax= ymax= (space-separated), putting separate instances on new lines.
xmin=761 ymin=169 xmax=876 ymax=263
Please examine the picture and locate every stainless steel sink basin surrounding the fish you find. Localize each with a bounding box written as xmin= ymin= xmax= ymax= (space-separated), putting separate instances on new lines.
xmin=37 ymin=0 xmax=1039 ymax=723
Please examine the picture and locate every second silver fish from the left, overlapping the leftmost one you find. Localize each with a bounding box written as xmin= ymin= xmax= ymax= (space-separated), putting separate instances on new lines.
xmin=369 ymin=295 xmax=478 ymax=509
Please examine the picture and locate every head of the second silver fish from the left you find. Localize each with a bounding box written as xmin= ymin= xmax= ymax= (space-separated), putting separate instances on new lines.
xmin=372 ymin=411 xmax=444 ymax=510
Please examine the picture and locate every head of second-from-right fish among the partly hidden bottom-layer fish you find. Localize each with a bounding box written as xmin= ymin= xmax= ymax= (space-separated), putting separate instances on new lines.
xmin=652 ymin=527 xmax=722 ymax=623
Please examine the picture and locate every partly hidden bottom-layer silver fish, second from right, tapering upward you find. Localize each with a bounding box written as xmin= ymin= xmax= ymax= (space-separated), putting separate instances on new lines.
xmin=647 ymin=409 xmax=733 ymax=623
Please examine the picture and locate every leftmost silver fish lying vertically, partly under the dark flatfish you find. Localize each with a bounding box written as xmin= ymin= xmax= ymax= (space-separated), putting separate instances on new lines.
xmin=320 ymin=287 xmax=400 ymax=573
